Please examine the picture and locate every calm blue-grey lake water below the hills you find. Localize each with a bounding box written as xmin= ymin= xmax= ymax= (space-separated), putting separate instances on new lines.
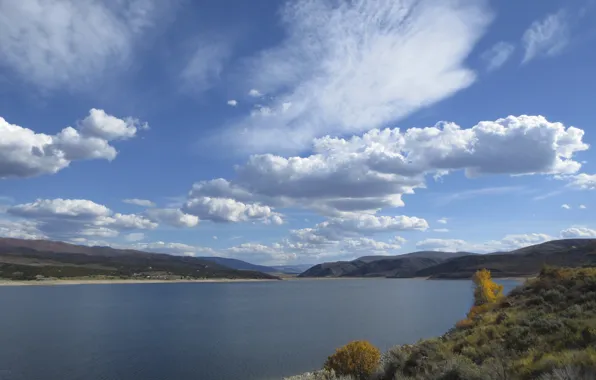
xmin=0 ymin=279 xmax=517 ymax=380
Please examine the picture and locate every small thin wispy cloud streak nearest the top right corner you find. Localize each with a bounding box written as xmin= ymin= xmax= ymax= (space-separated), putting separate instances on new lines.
xmin=522 ymin=11 xmax=569 ymax=63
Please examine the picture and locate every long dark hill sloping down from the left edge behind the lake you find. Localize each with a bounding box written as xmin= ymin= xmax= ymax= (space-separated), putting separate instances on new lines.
xmin=0 ymin=238 xmax=277 ymax=280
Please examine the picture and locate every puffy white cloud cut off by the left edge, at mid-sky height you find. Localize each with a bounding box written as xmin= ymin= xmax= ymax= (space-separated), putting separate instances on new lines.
xmin=0 ymin=109 xmax=147 ymax=179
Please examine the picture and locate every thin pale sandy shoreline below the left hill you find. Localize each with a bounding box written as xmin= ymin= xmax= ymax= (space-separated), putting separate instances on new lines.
xmin=0 ymin=278 xmax=280 ymax=287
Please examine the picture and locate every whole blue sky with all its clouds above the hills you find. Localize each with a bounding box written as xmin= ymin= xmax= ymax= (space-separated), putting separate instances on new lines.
xmin=0 ymin=0 xmax=596 ymax=265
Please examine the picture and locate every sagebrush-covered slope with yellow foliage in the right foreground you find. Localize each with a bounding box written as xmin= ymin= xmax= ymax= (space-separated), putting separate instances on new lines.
xmin=290 ymin=267 xmax=596 ymax=380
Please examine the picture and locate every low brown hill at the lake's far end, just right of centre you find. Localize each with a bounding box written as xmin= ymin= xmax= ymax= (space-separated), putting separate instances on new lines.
xmin=299 ymin=251 xmax=475 ymax=277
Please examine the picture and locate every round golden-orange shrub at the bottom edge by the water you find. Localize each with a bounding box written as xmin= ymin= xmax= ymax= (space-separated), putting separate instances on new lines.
xmin=325 ymin=340 xmax=381 ymax=379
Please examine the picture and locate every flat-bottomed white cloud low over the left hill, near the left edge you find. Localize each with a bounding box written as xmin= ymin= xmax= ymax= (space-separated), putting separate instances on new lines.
xmin=7 ymin=198 xmax=157 ymax=239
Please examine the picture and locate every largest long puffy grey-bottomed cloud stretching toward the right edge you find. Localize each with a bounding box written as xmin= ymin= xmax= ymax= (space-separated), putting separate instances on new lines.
xmin=191 ymin=115 xmax=588 ymax=217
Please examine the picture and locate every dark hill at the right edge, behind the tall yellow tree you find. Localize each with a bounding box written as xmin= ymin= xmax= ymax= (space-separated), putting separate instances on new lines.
xmin=415 ymin=239 xmax=596 ymax=278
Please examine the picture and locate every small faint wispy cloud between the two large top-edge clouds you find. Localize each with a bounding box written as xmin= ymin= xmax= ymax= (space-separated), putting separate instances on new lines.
xmin=181 ymin=36 xmax=236 ymax=93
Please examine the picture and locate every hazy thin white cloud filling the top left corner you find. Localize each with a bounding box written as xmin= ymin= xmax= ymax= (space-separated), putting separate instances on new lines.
xmin=0 ymin=0 xmax=169 ymax=89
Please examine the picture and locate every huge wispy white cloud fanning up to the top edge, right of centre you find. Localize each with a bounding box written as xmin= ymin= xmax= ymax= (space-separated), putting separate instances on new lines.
xmin=224 ymin=0 xmax=492 ymax=153
